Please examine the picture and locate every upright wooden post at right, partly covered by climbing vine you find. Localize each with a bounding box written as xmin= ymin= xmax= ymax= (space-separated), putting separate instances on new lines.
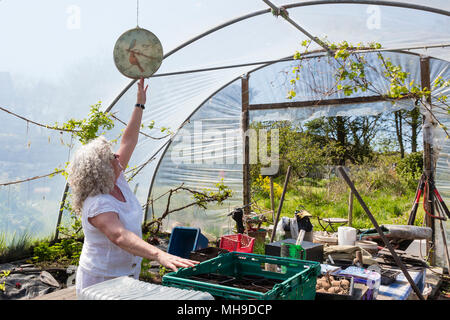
xmin=420 ymin=56 xmax=435 ymax=265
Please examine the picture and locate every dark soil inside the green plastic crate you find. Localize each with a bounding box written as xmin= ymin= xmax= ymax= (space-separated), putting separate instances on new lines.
xmin=189 ymin=273 xmax=283 ymax=293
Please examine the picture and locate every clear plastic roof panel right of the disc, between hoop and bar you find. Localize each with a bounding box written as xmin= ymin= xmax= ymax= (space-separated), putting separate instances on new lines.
xmin=158 ymin=9 xmax=308 ymax=73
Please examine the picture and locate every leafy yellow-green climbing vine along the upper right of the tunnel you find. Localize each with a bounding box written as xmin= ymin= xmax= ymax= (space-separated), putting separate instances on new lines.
xmin=287 ymin=39 xmax=450 ymax=138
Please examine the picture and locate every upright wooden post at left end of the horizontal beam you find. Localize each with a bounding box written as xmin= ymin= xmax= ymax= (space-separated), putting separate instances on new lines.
xmin=241 ymin=74 xmax=250 ymax=215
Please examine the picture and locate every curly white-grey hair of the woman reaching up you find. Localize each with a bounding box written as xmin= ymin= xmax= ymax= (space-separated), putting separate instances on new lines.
xmin=67 ymin=136 xmax=115 ymax=214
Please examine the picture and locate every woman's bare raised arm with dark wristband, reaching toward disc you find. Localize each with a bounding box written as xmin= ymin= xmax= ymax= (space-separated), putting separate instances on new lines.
xmin=117 ymin=78 xmax=148 ymax=169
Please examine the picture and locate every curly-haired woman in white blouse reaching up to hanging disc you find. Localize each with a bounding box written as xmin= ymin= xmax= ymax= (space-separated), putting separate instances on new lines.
xmin=68 ymin=78 xmax=198 ymax=295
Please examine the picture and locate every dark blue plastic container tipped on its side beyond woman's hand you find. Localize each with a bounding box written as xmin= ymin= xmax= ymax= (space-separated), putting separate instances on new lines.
xmin=167 ymin=227 xmax=209 ymax=258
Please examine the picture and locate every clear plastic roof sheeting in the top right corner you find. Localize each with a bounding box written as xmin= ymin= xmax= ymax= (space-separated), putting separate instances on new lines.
xmin=272 ymin=0 xmax=450 ymax=60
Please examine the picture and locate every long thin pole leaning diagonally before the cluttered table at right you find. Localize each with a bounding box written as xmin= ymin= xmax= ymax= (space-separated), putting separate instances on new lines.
xmin=338 ymin=167 xmax=425 ymax=300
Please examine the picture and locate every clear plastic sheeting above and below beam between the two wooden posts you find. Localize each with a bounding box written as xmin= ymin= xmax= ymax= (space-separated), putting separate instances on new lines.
xmin=249 ymin=52 xmax=420 ymax=123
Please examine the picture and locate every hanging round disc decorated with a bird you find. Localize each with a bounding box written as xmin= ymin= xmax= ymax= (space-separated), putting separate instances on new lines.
xmin=113 ymin=27 xmax=163 ymax=79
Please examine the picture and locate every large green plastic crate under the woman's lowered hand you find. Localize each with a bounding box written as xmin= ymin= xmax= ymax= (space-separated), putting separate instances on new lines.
xmin=162 ymin=252 xmax=320 ymax=300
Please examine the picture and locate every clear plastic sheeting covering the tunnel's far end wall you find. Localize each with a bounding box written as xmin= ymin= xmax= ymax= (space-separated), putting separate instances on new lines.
xmin=149 ymin=53 xmax=449 ymax=242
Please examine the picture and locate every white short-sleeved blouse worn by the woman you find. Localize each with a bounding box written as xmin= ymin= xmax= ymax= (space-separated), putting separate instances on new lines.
xmin=79 ymin=172 xmax=143 ymax=277
